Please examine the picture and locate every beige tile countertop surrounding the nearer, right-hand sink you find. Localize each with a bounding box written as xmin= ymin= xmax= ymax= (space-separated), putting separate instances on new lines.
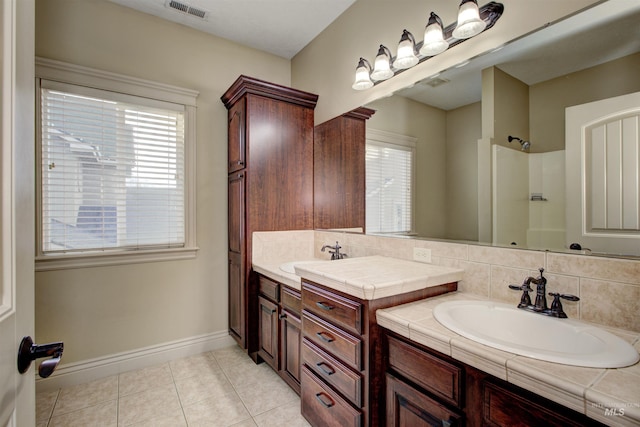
xmin=376 ymin=292 xmax=640 ymax=426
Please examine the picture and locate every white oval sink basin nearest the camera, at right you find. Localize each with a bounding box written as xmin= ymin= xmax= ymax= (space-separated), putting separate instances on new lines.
xmin=433 ymin=301 xmax=640 ymax=368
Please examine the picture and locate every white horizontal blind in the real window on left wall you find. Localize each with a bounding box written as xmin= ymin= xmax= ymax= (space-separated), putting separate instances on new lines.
xmin=40 ymin=80 xmax=185 ymax=254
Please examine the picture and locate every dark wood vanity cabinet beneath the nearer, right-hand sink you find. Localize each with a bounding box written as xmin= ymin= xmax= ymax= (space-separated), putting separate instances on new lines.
xmin=384 ymin=331 xmax=602 ymax=427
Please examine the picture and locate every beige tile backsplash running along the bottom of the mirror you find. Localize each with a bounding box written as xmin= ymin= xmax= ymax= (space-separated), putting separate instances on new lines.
xmin=314 ymin=231 xmax=640 ymax=332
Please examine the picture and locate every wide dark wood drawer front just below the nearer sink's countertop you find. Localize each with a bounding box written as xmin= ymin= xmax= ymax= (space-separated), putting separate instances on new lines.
xmin=388 ymin=337 xmax=463 ymax=407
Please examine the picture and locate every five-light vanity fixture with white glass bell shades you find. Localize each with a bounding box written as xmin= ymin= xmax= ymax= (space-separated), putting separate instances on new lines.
xmin=351 ymin=0 xmax=504 ymax=90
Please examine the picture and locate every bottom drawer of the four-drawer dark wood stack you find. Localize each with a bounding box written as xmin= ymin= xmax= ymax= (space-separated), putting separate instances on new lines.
xmin=300 ymin=366 xmax=362 ymax=427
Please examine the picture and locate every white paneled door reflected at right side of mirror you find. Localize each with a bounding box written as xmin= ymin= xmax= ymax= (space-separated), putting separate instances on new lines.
xmin=566 ymin=92 xmax=640 ymax=256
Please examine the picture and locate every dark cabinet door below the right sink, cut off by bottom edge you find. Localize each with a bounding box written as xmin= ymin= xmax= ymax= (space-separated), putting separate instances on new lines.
xmin=387 ymin=374 xmax=461 ymax=427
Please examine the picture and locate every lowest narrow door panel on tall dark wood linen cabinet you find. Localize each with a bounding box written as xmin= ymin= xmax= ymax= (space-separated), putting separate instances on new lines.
xmin=229 ymin=251 xmax=246 ymax=348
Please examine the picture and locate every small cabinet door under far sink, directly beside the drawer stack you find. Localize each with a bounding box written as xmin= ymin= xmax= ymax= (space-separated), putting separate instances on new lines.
xmin=280 ymin=310 xmax=301 ymax=389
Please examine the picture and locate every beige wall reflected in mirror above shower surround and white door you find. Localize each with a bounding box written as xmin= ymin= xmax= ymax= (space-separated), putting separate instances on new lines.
xmin=529 ymin=53 xmax=640 ymax=152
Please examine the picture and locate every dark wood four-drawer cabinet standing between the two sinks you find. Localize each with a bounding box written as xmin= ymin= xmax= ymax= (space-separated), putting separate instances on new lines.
xmin=301 ymin=278 xmax=457 ymax=427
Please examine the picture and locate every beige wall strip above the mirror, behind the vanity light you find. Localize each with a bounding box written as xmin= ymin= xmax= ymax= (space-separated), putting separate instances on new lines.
xmin=291 ymin=0 xmax=597 ymax=123
